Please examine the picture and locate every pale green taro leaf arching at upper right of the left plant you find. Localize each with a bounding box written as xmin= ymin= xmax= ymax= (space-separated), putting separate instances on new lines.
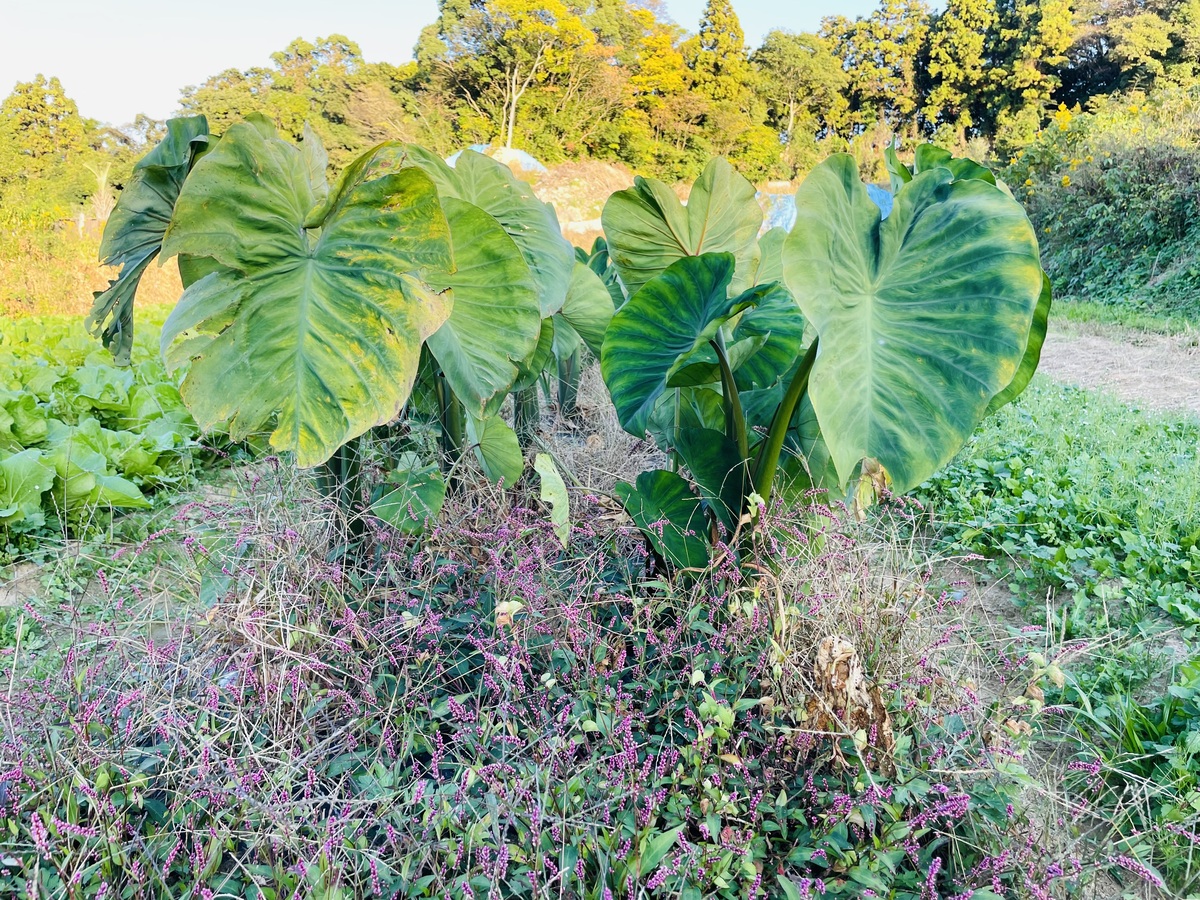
xmin=408 ymin=145 xmax=575 ymax=317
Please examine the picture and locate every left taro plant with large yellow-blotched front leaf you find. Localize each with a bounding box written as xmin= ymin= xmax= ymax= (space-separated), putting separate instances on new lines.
xmin=90 ymin=116 xmax=600 ymax=540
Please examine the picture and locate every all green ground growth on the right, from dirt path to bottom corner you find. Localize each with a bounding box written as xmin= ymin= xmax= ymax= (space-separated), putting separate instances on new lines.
xmin=924 ymin=380 xmax=1200 ymax=895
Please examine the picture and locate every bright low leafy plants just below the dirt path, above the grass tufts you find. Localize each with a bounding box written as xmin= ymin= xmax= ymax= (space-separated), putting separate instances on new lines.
xmin=924 ymin=380 xmax=1200 ymax=634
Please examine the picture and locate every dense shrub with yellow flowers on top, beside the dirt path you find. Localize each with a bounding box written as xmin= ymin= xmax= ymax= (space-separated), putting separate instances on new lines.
xmin=1006 ymin=91 xmax=1200 ymax=316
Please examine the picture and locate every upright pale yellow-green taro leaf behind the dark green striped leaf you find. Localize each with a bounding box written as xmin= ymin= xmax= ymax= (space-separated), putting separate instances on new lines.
xmin=601 ymin=158 xmax=762 ymax=296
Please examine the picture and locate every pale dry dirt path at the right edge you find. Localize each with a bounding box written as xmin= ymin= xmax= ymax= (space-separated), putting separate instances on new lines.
xmin=1039 ymin=326 xmax=1200 ymax=415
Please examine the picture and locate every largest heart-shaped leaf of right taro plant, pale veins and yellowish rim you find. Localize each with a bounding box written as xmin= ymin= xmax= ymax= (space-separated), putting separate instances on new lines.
xmin=784 ymin=154 xmax=1042 ymax=493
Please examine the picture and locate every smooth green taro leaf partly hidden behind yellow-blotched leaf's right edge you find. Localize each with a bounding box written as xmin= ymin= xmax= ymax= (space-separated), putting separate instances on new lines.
xmin=427 ymin=197 xmax=541 ymax=416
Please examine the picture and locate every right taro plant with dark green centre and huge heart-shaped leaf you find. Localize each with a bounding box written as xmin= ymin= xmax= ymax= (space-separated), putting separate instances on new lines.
xmin=601 ymin=150 xmax=1050 ymax=568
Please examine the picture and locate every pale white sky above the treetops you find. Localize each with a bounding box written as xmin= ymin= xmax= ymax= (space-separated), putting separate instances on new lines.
xmin=0 ymin=0 xmax=877 ymax=125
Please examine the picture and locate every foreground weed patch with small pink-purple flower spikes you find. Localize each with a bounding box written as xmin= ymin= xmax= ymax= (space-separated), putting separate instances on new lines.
xmin=0 ymin=466 xmax=1099 ymax=900
